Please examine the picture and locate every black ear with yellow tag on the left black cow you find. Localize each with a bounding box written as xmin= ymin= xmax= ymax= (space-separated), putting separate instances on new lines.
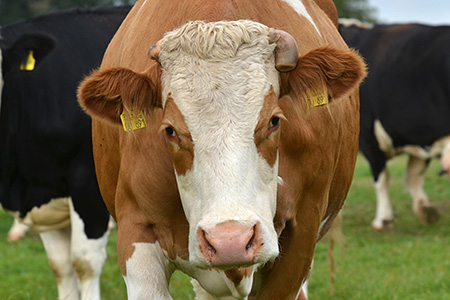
xmin=3 ymin=33 xmax=56 ymax=72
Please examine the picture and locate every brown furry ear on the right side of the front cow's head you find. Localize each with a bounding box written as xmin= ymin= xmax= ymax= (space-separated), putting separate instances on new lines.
xmin=289 ymin=47 xmax=367 ymax=106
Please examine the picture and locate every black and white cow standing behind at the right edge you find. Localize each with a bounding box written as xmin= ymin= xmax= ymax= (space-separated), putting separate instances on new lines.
xmin=340 ymin=24 xmax=450 ymax=230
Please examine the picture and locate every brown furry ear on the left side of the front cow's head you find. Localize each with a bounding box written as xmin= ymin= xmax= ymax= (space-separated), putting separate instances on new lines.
xmin=78 ymin=68 xmax=160 ymax=125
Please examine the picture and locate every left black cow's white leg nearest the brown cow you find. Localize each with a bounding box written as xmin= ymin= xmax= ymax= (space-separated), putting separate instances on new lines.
xmin=69 ymin=201 xmax=109 ymax=300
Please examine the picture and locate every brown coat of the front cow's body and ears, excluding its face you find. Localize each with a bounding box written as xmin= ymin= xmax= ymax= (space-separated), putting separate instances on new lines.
xmin=79 ymin=0 xmax=365 ymax=300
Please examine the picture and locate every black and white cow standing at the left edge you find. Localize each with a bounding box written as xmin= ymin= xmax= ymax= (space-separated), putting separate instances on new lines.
xmin=0 ymin=7 xmax=130 ymax=300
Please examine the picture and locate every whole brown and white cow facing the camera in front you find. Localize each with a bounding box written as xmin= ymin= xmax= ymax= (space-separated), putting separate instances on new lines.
xmin=79 ymin=0 xmax=365 ymax=300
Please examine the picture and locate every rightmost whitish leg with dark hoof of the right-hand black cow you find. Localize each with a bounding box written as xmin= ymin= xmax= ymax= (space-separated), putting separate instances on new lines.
xmin=405 ymin=156 xmax=439 ymax=224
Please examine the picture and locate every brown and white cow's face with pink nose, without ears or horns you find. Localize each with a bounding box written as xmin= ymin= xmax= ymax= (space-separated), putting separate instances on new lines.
xmin=158 ymin=22 xmax=283 ymax=267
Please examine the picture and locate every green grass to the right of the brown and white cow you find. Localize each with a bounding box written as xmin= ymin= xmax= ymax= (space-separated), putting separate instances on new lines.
xmin=309 ymin=157 xmax=450 ymax=300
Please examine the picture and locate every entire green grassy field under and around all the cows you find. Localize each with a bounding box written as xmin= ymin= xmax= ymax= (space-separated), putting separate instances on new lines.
xmin=0 ymin=157 xmax=450 ymax=300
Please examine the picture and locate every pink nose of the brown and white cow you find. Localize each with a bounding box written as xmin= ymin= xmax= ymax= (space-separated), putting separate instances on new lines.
xmin=197 ymin=221 xmax=263 ymax=268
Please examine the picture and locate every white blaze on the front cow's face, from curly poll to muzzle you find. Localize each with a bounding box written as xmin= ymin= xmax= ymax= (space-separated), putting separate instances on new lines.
xmin=159 ymin=21 xmax=279 ymax=263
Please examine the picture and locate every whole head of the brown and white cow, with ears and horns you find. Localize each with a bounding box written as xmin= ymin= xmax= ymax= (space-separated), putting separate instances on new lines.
xmin=79 ymin=21 xmax=364 ymax=268
